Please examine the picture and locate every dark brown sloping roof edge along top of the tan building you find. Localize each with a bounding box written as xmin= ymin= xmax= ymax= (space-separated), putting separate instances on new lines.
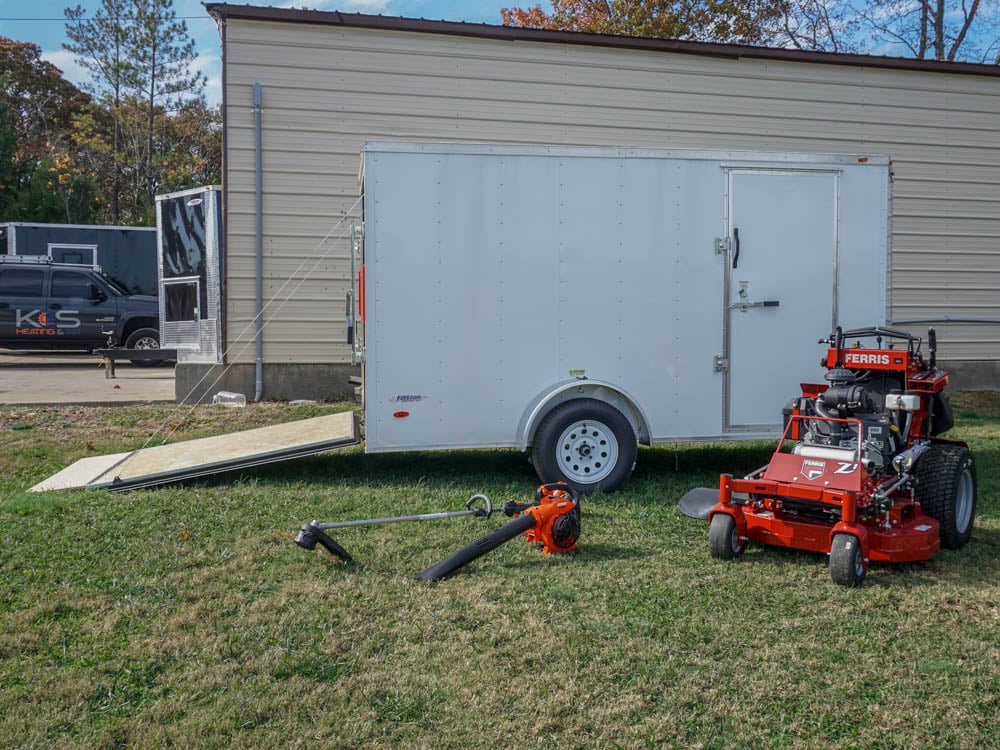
xmin=205 ymin=3 xmax=1000 ymax=76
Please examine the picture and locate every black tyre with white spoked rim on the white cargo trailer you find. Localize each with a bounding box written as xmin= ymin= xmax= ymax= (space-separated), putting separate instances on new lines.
xmin=531 ymin=398 xmax=636 ymax=492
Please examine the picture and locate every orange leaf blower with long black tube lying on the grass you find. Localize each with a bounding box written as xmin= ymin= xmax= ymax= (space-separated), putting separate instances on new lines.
xmin=417 ymin=482 xmax=580 ymax=581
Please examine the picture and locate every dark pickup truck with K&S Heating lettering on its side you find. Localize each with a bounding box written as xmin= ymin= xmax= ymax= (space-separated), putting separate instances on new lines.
xmin=0 ymin=255 xmax=160 ymax=358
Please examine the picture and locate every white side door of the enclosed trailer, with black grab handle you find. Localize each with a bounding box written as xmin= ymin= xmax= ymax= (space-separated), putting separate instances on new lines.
xmin=725 ymin=169 xmax=840 ymax=432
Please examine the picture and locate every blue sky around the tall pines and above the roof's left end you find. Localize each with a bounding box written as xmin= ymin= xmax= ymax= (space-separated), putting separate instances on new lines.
xmin=0 ymin=0 xmax=512 ymax=104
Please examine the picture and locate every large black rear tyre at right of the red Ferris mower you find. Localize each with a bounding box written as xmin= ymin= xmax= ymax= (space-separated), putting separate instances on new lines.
xmin=915 ymin=445 xmax=976 ymax=549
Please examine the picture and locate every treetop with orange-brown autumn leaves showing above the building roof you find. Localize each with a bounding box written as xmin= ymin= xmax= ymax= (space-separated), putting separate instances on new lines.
xmin=500 ymin=0 xmax=785 ymax=44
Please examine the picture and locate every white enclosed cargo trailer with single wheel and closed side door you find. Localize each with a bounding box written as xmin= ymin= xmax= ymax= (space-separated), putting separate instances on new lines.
xmin=352 ymin=143 xmax=890 ymax=490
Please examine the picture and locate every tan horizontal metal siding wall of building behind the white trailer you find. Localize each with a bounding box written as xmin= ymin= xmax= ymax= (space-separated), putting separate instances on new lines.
xmin=197 ymin=4 xmax=1000 ymax=397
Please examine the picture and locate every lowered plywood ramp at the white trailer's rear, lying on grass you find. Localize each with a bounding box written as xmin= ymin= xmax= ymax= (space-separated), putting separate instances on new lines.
xmin=31 ymin=412 xmax=360 ymax=492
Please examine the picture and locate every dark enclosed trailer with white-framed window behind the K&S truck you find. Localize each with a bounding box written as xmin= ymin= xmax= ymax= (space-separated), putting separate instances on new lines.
xmin=0 ymin=221 xmax=158 ymax=296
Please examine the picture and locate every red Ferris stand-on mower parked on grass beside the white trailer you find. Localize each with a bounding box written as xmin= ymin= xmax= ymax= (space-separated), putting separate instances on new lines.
xmin=680 ymin=327 xmax=976 ymax=586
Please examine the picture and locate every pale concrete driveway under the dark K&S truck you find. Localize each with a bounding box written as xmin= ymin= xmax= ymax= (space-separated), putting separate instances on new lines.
xmin=0 ymin=349 xmax=175 ymax=405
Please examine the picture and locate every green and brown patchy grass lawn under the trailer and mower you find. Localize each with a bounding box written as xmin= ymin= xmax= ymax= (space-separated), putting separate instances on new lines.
xmin=0 ymin=394 xmax=1000 ymax=750
